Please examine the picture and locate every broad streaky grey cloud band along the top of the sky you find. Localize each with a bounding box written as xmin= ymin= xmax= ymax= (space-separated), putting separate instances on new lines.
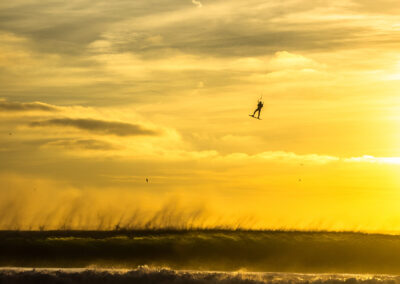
xmin=0 ymin=0 xmax=393 ymax=61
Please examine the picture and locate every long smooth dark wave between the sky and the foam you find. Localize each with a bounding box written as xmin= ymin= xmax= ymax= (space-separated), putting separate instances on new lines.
xmin=0 ymin=230 xmax=400 ymax=274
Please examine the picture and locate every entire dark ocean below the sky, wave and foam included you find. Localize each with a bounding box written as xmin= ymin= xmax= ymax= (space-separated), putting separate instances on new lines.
xmin=0 ymin=230 xmax=400 ymax=284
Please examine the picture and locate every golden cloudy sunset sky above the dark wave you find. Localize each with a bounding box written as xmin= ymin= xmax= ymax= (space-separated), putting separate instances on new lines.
xmin=0 ymin=0 xmax=400 ymax=232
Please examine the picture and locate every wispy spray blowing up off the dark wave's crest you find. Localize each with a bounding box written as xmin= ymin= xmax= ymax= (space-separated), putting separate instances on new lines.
xmin=0 ymin=189 xmax=231 ymax=231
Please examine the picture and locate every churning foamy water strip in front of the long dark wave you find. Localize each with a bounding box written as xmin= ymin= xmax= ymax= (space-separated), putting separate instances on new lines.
xmin=0 ymin=266 xmax=400 ymax=284
